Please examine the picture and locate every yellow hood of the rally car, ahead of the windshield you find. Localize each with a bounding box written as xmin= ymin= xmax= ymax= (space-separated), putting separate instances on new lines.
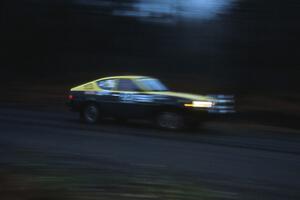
xmin=147 ymin=91 xmax=213 ymax=101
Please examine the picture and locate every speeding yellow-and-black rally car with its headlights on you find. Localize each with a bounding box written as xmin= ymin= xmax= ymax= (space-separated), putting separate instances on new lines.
xmin=68 ymin=76 xmax=234 ymax=130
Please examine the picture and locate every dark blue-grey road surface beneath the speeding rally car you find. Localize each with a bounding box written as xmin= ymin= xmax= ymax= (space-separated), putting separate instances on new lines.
xmin=0 ymin=107 xmax=300 ymax=199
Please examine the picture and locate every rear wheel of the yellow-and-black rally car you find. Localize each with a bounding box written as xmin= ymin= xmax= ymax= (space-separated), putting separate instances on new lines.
xmin=80 ymin=103 xmax=100 ymax=124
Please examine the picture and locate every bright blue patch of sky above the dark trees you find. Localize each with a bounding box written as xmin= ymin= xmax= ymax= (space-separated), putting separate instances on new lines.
xmin=75 ymin=0 xmax=233 ymax=22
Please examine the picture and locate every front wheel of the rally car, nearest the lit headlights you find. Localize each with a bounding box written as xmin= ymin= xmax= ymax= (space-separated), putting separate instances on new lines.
xmin=156 ymin=111 xmax=186 ymax=131
